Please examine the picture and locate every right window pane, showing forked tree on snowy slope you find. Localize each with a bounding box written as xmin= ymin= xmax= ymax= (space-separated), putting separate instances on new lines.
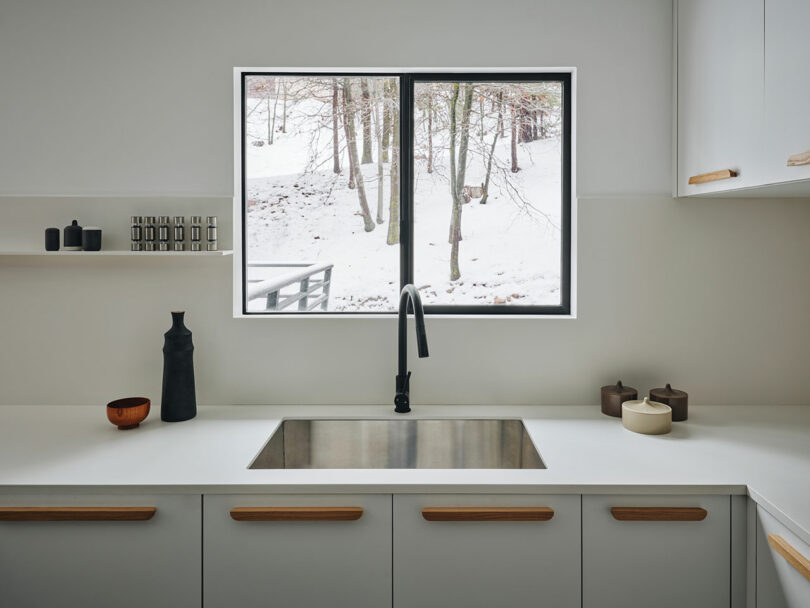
xmin=413 ymin=81 xmax=563 ymax=306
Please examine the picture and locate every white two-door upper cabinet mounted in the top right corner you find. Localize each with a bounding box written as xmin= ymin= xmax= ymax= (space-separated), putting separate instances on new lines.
xmin=676 ymin=0 xmax=810 ymax=196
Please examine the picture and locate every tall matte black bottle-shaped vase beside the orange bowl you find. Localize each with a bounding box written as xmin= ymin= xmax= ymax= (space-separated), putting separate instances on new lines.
xmin=160 ymin=311 xmax=197 ymax=422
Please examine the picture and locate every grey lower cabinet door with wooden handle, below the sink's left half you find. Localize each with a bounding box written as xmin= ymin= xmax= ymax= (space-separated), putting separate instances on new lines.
xmin=203 ymin=494 xmax=391 ymax=608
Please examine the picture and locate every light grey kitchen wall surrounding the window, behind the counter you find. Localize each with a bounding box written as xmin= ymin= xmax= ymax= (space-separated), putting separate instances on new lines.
xmin=0 ymin=0 xmax=810 ymax=404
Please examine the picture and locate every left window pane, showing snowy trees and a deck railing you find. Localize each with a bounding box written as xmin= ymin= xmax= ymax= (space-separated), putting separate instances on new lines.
xmin=244 ymin=75 xmax=400 ymax=312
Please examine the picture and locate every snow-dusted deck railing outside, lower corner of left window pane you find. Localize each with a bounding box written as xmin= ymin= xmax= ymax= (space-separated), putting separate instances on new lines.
xmin=247 ymin=262 xmax=333 ymax=312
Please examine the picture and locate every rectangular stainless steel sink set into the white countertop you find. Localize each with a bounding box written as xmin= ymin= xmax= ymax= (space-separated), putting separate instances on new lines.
xmin=250 ymin=418 xmax=546 ymax=469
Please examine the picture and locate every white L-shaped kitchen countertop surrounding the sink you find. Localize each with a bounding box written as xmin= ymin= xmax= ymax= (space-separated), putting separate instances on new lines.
xmin=0 ymin=405 xmax=810 ymax=543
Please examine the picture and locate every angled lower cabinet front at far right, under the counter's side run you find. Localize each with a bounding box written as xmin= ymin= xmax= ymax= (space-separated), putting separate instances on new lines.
xmin=757 ymin=507 xmax=810 ymax=608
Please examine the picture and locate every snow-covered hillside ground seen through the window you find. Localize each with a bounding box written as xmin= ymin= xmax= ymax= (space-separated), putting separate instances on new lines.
xmin=247 ymin=88 xmax=561 ymax=311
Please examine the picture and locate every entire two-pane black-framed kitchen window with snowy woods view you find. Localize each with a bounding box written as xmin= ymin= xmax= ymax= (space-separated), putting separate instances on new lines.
xmin=236 ymin=70 xmax=572 ymax=315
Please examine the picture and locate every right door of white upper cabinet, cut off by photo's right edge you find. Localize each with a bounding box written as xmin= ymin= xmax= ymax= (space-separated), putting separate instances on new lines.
xmin=765 ymin=0 xmax=810 ymax=188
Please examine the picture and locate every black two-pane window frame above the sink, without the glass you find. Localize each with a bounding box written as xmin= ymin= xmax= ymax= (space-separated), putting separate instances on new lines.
xmin=240 ymin=70 xmax=573 ymax=317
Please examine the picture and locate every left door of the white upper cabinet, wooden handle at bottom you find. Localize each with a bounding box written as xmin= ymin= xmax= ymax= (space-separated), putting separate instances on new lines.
xmin=677 ymin=0 xmax=764 ymax=196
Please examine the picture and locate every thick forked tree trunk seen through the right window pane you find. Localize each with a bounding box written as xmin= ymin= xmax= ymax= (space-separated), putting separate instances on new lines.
xmin=450 ymin=82 xmax=475 ymax=281
